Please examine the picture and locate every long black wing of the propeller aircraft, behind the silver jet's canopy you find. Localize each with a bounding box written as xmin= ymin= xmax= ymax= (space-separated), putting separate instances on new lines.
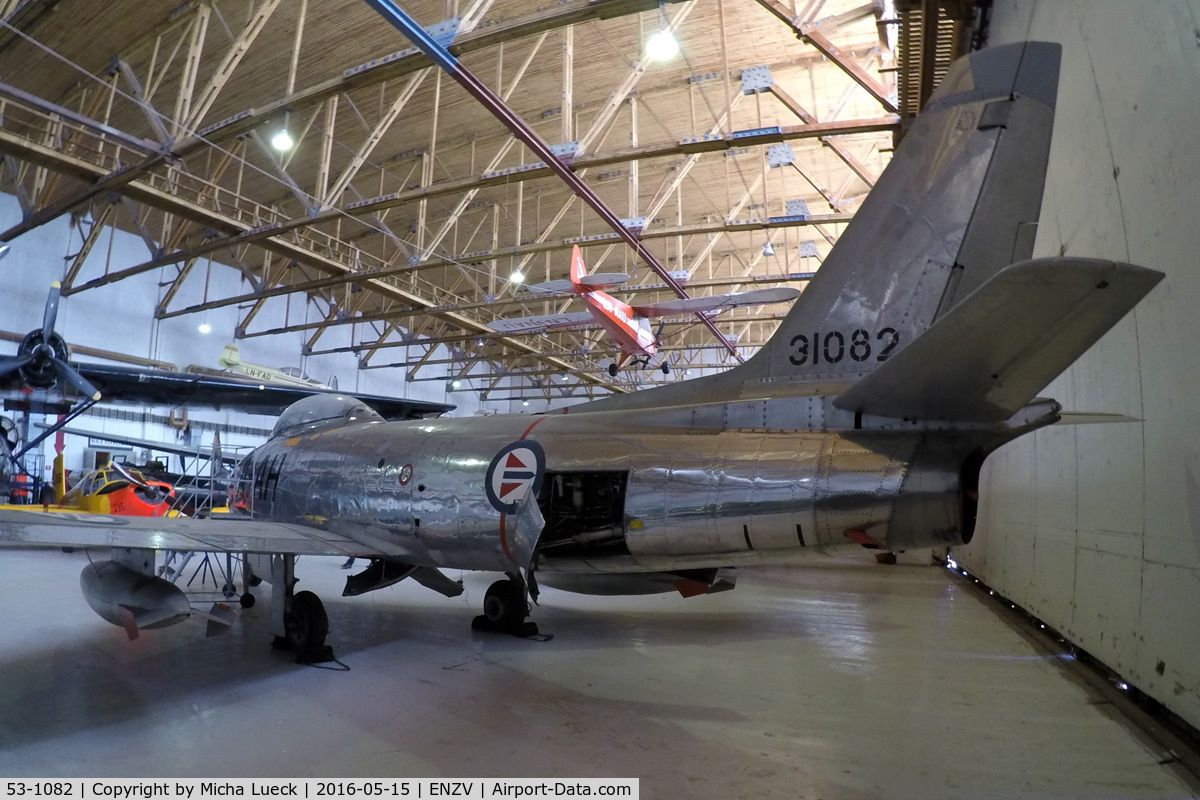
xmin=65 ymin=363 xmax=455 ymax=420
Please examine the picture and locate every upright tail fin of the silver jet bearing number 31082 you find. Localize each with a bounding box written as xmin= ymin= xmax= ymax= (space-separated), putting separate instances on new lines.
xmin=744 ymin=42 xmax=1061 ymax=384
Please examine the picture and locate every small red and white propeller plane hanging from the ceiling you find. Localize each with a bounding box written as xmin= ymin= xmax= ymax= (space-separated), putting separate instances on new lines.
xmin=488 ymin=245 xmax=800 ymax=377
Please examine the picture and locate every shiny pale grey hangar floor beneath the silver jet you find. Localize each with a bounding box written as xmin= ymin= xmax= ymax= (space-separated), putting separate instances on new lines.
xmin=0 ymin=551 xmax=1195 ymax=800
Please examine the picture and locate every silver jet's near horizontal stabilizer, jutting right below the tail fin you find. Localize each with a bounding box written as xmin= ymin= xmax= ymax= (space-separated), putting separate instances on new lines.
xmin=834 ymin=258 xmax=1163 ymax=422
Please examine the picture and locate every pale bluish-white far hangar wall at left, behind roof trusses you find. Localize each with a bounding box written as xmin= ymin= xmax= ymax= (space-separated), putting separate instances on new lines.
xmin=0 ymin=194 xmax=479 ymax=482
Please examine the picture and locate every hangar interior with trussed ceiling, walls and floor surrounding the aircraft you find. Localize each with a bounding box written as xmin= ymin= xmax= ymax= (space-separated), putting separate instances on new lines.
xmin=0 ymin=0 xmax=1200 ymax=798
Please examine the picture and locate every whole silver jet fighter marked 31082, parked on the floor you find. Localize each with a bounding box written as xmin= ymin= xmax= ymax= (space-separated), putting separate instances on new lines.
xmin=0 ymin=42 xmax=1163 ymax=654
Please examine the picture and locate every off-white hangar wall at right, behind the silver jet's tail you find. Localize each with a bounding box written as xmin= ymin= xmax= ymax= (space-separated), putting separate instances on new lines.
xmin=959 ymin=0 xmax=1200 ymax=727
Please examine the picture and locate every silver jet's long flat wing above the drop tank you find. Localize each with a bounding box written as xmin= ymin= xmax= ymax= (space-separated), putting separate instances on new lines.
xmin=0 ymin=509 xmax=404 ymax=557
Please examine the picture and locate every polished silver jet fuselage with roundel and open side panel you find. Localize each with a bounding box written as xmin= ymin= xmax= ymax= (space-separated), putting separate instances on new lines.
xmin=231 ymin=398 xmax=978 ymax=573
